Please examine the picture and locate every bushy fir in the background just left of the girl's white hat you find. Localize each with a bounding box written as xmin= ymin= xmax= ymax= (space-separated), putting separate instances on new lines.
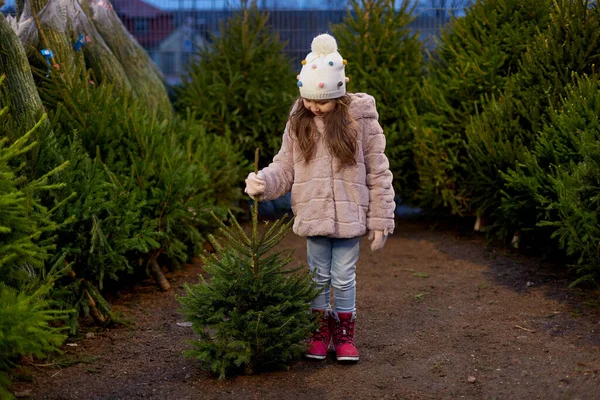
xmin=176 ymin=1 xmax=297 ymax=167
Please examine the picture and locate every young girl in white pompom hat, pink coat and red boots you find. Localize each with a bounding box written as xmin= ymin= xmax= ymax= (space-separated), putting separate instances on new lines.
xmin=246 ymin=34 xmax=395 ymax=361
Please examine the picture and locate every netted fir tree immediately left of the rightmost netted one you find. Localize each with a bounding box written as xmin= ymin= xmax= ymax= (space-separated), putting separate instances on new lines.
xmin=61 ymin=0 xmax=131 ymax=94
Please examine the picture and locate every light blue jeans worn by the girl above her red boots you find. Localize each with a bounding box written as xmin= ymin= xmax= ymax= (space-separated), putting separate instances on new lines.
xmin=306 ymin=236 xmax=360 ymax=312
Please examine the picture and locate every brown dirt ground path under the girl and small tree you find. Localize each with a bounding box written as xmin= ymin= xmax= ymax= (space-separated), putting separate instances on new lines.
xmin=13 ymin=221 xmax=600 ymax=400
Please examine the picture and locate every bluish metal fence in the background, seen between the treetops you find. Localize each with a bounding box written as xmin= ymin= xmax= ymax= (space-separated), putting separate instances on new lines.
xmin=0 ymin=0 xmax=467 ymax=84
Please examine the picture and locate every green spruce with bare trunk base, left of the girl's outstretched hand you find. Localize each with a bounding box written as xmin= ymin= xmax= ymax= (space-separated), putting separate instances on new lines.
xmin=122 ymin=111 xmax=247 ymax=290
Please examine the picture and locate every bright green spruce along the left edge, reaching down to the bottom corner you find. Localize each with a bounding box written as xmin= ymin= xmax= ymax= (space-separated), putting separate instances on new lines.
xmin=0 ymin=97 xmax=67 ymax=399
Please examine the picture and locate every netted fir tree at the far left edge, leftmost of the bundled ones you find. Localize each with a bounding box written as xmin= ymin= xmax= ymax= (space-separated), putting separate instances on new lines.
xmin=0 ymin=13 xmax=49 ymax=132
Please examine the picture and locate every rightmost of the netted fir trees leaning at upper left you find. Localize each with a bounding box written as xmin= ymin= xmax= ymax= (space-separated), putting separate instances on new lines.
xmin=86 ymin=0 xmax=172 ymax=117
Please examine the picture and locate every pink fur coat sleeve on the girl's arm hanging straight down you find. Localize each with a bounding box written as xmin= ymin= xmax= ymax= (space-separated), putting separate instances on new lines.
xmin=363 ymin=118 xmax=396 ymax=234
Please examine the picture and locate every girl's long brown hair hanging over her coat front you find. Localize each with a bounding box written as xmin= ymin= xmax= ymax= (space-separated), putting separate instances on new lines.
xmin=290 ymin=95 xmax=358 ymax=165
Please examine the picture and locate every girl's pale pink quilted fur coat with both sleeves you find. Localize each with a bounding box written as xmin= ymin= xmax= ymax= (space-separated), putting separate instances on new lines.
xmin=261 ymin=93 xmax=396 ymax=238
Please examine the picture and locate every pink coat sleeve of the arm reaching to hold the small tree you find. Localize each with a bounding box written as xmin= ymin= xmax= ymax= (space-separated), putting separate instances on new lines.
xmin=261 ymin=127 xmax=294 ymax=200
